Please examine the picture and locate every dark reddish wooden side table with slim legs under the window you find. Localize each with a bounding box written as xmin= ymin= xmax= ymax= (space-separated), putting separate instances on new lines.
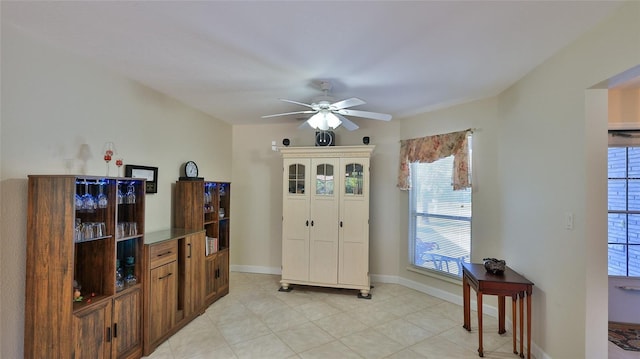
xmin=462 ymin=263 xmax=533 ymax=358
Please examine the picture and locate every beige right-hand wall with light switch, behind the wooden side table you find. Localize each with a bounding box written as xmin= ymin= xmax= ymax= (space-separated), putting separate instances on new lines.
xmin=498 ymin=2 xmax=640 ymax=358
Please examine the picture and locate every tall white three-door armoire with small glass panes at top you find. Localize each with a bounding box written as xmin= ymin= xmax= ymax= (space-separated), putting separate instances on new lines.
xmin=280 ymin=146 xmax=374 ymax=298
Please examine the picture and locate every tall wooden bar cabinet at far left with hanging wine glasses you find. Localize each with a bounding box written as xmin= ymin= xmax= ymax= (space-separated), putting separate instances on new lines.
xmin=24 ymin=175 xmax=146 ymax=358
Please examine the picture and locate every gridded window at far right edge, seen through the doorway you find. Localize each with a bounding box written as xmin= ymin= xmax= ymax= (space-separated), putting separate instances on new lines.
xmin=607 ymin=147 xmax=640 ymax=277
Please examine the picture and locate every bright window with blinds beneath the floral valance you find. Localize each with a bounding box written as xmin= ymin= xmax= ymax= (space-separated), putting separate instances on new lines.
xmin=409 ymin=154 xmax=471 ymax=277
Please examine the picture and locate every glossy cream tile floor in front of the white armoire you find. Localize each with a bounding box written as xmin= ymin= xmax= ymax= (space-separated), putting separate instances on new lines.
xmin=148 ymin=272 xmax=626 ymax=359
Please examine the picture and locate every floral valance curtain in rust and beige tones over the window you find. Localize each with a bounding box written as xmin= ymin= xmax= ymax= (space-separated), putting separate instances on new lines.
xmin=398 ymin=129 xmax=471 ymax=191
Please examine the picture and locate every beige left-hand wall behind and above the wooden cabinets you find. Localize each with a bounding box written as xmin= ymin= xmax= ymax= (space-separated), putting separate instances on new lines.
xmin=0 ymin=21 xmax=231 ymax=358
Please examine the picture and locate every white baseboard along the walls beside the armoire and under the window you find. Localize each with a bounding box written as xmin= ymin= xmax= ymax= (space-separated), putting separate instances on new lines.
xmin=230 ymin=265 xmax=551 ymax=359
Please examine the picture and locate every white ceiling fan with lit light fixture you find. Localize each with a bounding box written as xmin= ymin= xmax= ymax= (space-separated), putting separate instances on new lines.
xmin=262 ymin=81 xmax=391 ymax=131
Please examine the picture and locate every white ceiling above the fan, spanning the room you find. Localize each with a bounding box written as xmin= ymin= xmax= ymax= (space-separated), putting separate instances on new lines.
xmin=1 ymin=0 xmax=620 ymax=124
